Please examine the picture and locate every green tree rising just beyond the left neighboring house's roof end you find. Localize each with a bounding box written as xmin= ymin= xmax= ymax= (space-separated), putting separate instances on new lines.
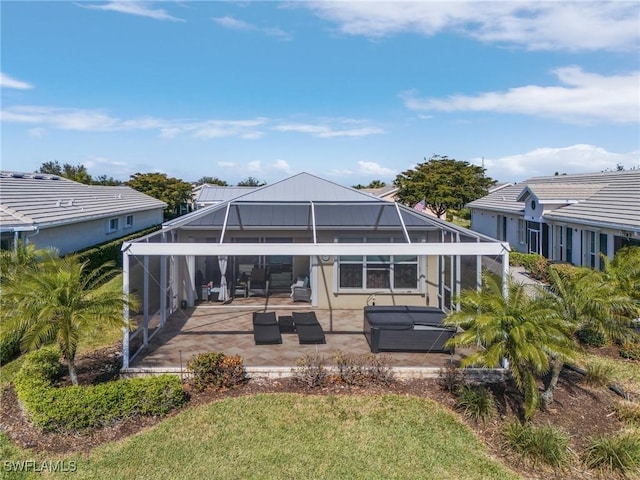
xmin=126 ymin=173 xmax=192 ymax=219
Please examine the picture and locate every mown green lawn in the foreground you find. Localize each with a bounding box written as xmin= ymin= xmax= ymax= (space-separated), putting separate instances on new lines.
xmin=0 ymin=394 xmax=519 ymax=480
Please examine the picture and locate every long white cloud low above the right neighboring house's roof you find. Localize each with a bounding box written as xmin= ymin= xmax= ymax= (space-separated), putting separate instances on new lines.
xmin=482 ymin=144 xmax=640 ymax=181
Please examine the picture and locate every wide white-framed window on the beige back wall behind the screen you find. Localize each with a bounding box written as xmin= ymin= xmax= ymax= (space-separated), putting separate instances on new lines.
xmin=338 ymin=238 xmax=418 ymax=290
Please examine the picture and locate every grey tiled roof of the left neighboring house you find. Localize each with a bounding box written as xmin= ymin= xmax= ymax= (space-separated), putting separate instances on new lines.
xmin=0 ymin=171 xmax=166 ymax=231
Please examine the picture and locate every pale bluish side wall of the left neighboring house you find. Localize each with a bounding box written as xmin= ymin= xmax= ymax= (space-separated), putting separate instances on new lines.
xmin=27 ymin=209 xmax=163 ymax=255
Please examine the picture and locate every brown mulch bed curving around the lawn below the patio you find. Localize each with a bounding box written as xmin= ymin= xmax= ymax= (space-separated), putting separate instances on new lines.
xmin=0 ymin=345 xmax=623 ymax=479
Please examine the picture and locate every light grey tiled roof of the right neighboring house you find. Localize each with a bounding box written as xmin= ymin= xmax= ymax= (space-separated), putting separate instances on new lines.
xmin=467 ymin=170 xmax=640 ymax=229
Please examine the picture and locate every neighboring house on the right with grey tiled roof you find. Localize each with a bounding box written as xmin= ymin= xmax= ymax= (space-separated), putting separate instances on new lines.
xmin=467 ymin=170 xmax=640 ymax=268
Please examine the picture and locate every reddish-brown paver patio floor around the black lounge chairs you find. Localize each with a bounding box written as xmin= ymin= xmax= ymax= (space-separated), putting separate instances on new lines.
xmin=123 ymin=294 xmax=468 ymax=376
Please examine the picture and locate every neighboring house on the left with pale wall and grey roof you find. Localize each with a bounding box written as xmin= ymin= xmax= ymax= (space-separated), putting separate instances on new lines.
xmin=0 ymin=172 xmax=166 ymax=255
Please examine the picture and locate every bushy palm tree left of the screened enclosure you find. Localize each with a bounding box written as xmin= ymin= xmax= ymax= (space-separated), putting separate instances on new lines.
xmin=2 ymin=255 xmax=136 ymax=385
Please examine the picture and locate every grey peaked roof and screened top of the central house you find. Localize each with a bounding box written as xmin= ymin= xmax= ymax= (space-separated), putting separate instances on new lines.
xmin=131 ymin=173 xmax=507 ymax=254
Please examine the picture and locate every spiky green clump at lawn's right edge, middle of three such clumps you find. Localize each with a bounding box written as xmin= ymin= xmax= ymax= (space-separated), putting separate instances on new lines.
xmin=503 ymin=422 xmax=569 ymax=468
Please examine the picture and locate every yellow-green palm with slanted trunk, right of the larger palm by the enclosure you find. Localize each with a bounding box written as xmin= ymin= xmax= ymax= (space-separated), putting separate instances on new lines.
xmin=542 ymin=268 xmax=638 ymax=408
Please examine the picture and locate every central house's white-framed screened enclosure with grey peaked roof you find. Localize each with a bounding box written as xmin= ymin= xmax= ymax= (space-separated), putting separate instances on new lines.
xmin=123 ymin=173 xmax=509 ymax=368
